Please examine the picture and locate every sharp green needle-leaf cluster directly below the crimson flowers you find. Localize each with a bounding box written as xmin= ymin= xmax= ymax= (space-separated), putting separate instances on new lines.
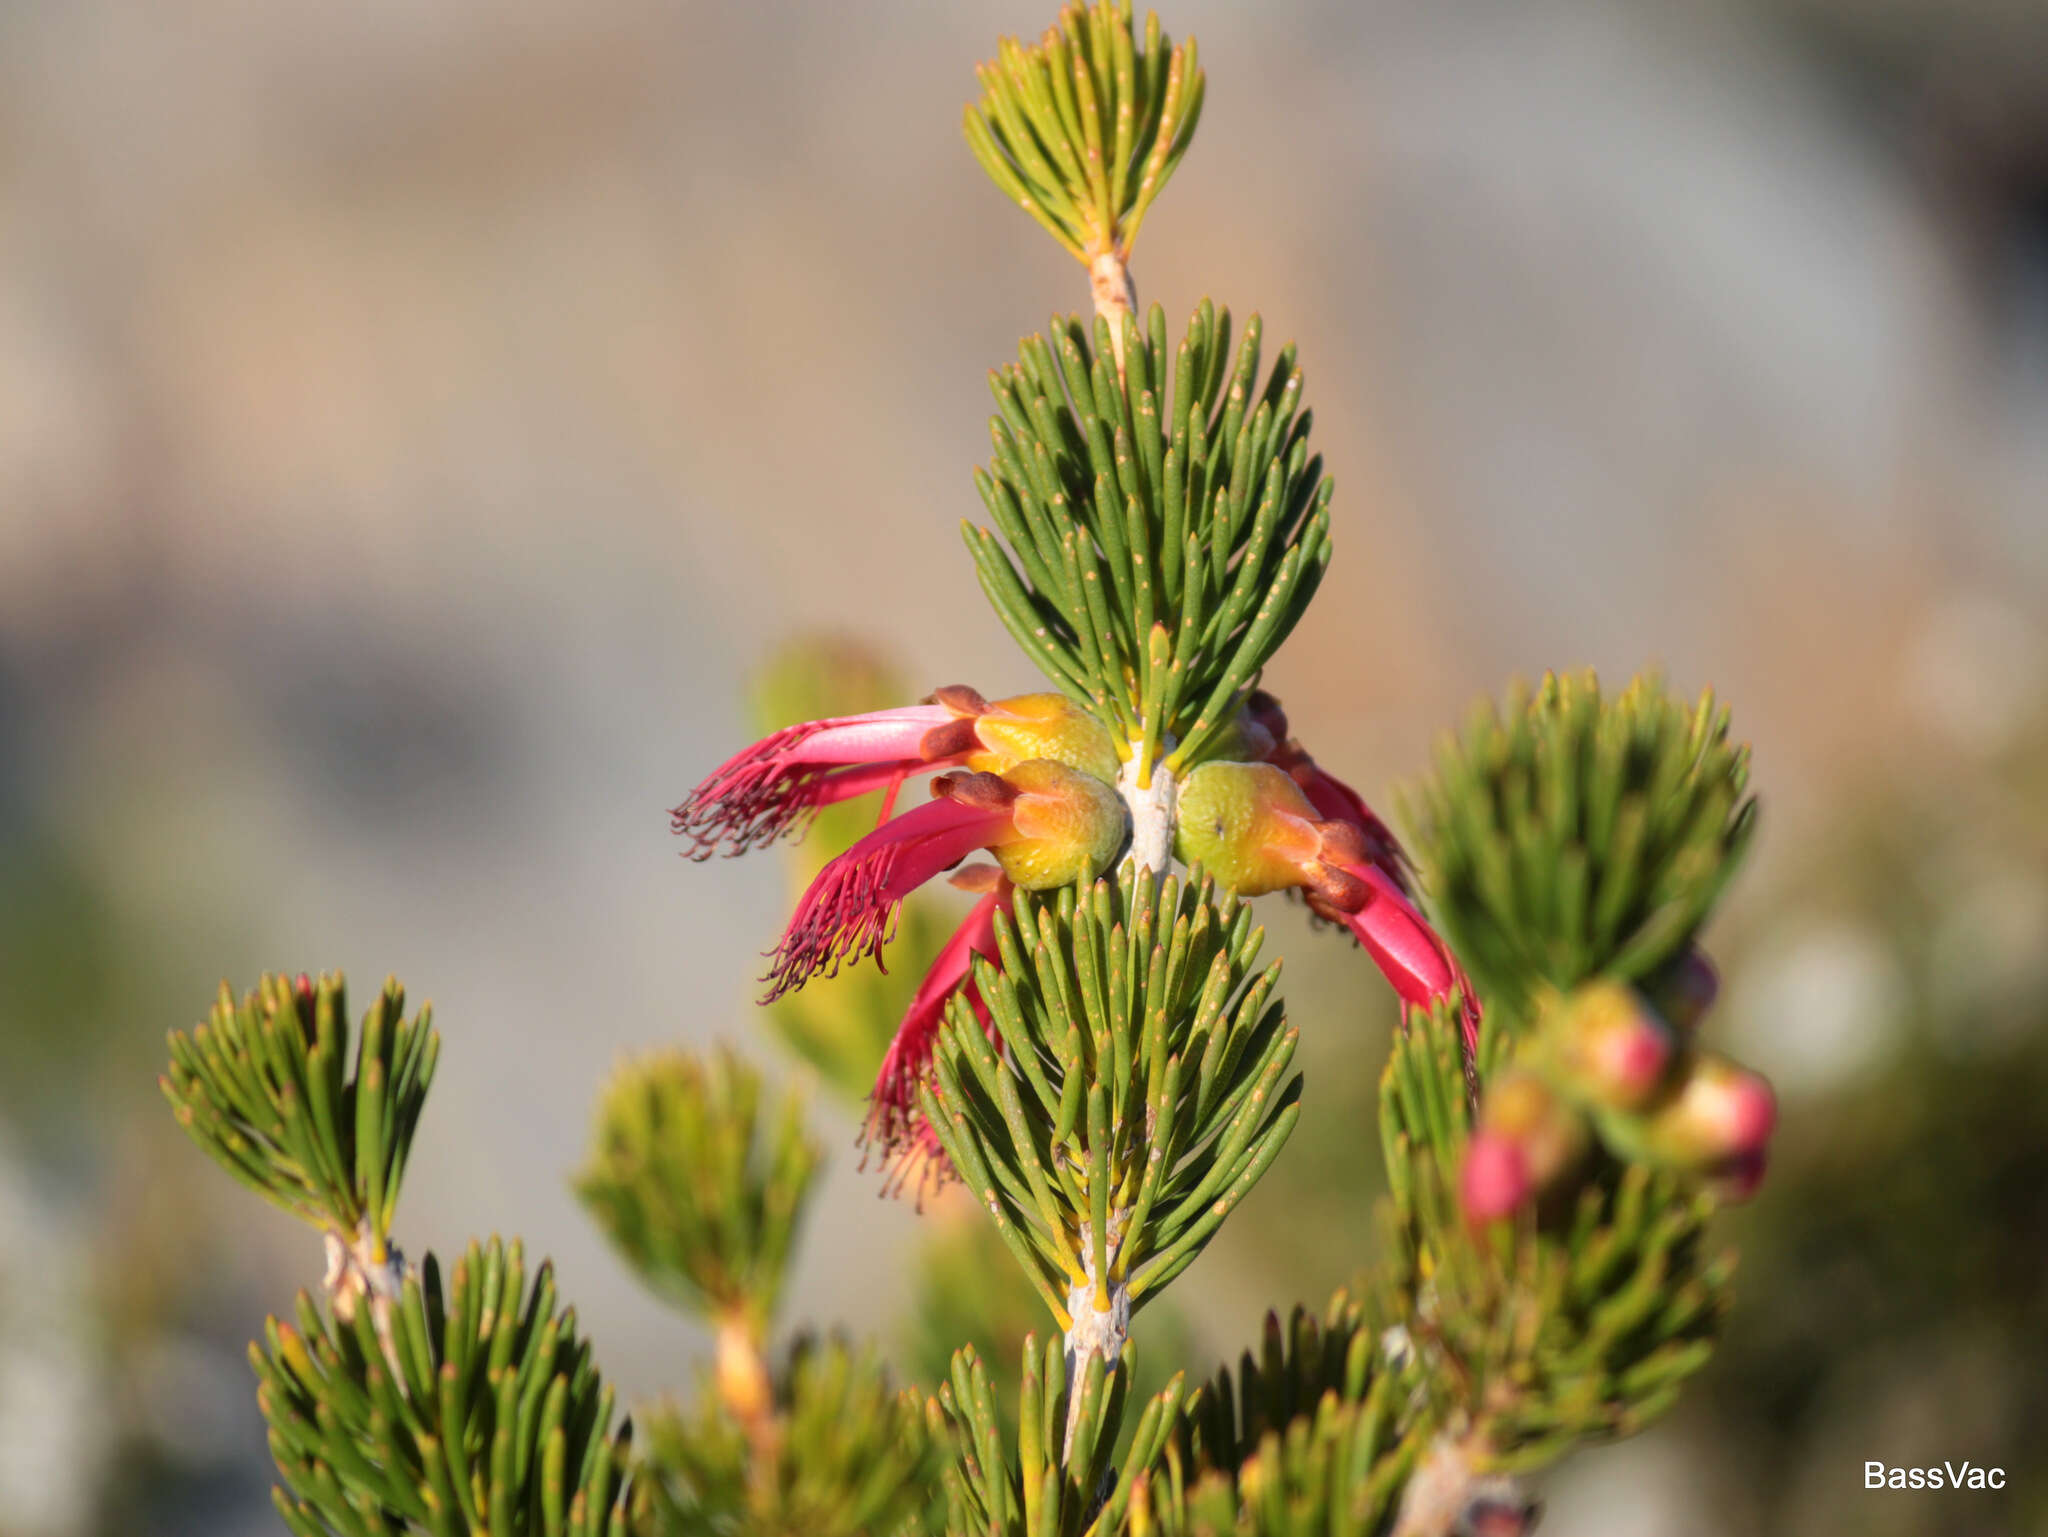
xmin=924 ymin=863 xmax=1300 ymax=1328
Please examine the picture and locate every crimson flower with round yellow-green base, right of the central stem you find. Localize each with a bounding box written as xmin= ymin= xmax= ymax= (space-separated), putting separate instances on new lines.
xmin=1178 ymin=762 xmax=1481 ymax=1062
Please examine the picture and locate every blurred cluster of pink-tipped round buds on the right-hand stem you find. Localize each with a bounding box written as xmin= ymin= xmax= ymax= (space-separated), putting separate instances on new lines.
xmin=1458 ymin=951 xmax=1778 ymax=1221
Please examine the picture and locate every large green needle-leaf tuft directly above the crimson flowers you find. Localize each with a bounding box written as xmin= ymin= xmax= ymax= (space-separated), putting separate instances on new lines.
xmin=965 ymin=299 xmax=1331 ymax=783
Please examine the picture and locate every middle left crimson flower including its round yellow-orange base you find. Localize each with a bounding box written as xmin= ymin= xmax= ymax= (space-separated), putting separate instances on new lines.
xmin=762 ymin=758 xmax=1128 ymax=1002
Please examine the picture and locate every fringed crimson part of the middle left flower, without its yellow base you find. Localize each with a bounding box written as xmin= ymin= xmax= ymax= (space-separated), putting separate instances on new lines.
xmin=762 ymin=799 xmax=1014 ymax=1002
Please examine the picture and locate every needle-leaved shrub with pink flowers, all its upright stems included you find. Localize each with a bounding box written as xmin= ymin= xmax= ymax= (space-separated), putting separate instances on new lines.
xmin=164 ymin=0 xmax=1776 ymax=1537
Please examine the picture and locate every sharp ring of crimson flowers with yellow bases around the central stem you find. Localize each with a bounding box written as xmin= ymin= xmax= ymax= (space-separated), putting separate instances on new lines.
xmin=672 ymin=687 xmax=1479 ymax=1189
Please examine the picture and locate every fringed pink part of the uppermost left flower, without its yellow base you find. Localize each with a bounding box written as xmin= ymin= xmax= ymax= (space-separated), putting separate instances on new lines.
xmin=670 ymin=705 xmax=963 ymax=859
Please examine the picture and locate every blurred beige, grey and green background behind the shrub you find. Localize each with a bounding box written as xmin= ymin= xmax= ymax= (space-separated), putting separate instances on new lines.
xmin=0 ymin=0 xmax=2048 ymax=1537
